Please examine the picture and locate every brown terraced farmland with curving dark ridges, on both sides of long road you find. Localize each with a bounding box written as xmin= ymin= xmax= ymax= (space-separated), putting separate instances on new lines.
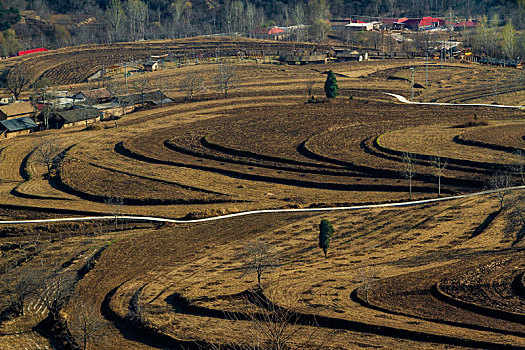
xmin=0 ymin=38 xmax=525 ymax=349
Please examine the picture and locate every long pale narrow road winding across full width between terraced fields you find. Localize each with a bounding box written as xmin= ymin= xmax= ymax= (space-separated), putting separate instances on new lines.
xmin=0 ymin=186 xmax=525 ymax=225
